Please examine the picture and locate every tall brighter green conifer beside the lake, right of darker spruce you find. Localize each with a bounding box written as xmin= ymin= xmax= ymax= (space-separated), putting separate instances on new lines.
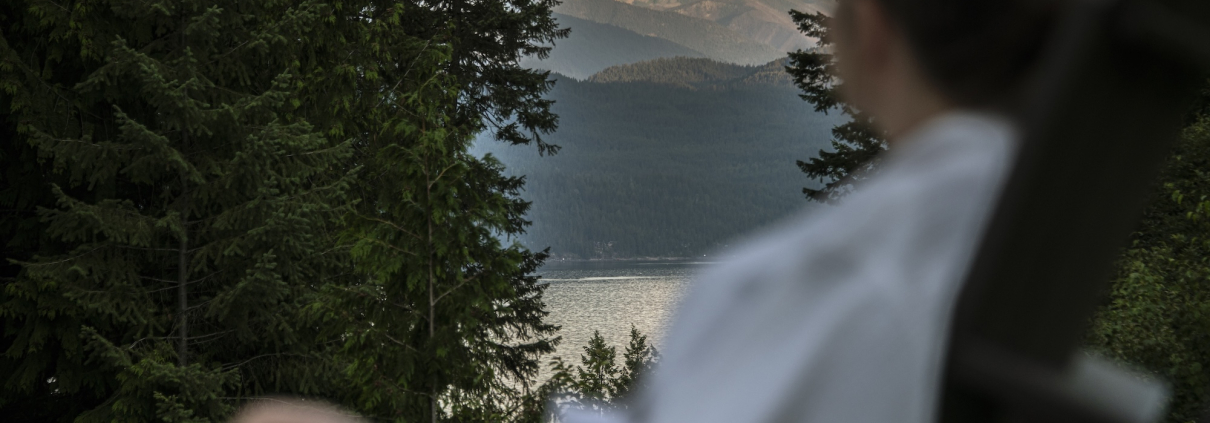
xmin=300 ymin=0 xmax=566 ymax=422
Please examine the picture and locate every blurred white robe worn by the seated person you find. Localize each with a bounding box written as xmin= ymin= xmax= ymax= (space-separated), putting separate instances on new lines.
xmin=563 ymin=112 xmax=1016 ymax=423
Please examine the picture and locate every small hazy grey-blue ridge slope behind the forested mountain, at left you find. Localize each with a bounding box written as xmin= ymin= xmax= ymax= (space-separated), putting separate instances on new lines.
xmin=522 ymin=13 xmax=703 ymax=80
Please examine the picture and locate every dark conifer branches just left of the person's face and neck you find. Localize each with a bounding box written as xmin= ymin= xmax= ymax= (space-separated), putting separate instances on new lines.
xmin=785 ymin=11 xmax=887 ymax=203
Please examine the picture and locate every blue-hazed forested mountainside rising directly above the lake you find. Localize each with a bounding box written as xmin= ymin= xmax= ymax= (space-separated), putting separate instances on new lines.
xmin=476 ymin=58 xmax=841 ymax=259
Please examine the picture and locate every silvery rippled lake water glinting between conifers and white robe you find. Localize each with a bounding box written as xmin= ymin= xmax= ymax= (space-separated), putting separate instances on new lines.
xmin=537 ymin=261 xmax=708 ymax=381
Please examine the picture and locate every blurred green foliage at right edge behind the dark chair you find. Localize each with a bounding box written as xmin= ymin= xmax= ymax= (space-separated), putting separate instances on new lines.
xmin=1089 ymin=113 xmax=1210 ymax=423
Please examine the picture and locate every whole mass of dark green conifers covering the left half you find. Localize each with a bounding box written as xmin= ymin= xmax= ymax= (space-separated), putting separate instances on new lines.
xmin=0 ymin=0 xmax=565 ymax=422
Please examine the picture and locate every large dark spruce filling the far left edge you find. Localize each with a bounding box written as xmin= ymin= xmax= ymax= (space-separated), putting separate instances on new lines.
xmin=0 ymin=0 xmax=350 ymax=422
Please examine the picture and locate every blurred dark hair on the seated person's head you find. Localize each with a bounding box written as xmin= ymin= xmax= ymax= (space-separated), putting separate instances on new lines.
xmin=871 ymin=0 xmax=1060 ymax=106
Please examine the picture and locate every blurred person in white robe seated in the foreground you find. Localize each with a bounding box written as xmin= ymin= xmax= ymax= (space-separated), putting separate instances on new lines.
xmin=563 ymin=0 xmax=1055 ymax=423
